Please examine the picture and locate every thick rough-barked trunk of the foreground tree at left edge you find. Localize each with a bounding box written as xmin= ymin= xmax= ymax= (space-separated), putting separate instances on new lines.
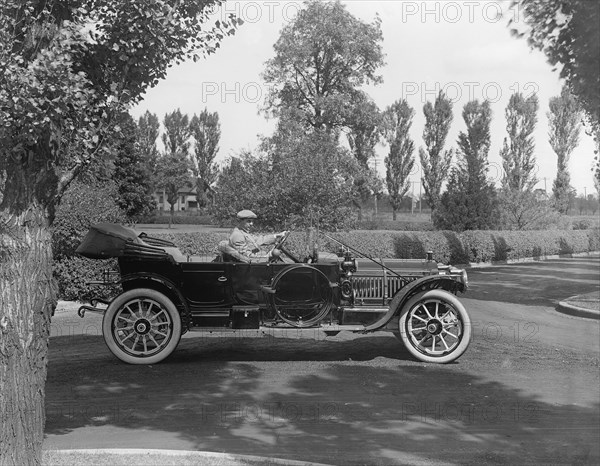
xmin=0 ymin=205 xmax=57 ymax=465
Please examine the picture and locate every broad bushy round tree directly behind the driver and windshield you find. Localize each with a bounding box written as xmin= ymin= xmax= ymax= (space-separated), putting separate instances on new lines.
xmin=213 ymin=127 xmax=360 ymax=229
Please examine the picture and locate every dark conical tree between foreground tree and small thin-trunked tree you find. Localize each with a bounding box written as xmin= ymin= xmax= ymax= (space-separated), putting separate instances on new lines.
xmin=113 ymin=113 xmax=156 ymax=221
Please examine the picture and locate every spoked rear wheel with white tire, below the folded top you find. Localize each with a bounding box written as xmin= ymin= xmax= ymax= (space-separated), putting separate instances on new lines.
xmin=102 ymin=288 xmax=181 ymax=364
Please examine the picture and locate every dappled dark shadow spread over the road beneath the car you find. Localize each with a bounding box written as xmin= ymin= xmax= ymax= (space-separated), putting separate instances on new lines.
xmin=46 ymin=336 xmax=600 ymax=465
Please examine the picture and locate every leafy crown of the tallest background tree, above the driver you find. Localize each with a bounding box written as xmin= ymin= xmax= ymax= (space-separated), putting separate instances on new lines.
xmin=264 ymin=0 xmax=383 ymax=132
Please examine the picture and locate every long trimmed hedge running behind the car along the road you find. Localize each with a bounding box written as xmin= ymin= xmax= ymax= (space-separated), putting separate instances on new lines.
xmin=54 ymin=228 xmax=600 ymax=300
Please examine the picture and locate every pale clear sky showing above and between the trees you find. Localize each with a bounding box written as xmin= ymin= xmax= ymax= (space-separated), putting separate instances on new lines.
xmin=131 ymin=0 xmax=595 ymax=196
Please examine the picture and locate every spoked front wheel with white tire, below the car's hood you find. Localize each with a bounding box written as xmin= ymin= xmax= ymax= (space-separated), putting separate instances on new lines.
xmin=398 ymin=290 xmax=471 ymax=363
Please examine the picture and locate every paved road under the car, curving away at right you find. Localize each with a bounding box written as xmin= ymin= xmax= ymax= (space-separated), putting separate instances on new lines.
xmin=44 ymin=257 xmax=600 ymax=465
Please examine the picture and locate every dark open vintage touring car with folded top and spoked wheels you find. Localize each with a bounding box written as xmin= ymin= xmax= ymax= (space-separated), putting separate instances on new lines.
xmin=77 ymin=224 xmax=471 ymax=364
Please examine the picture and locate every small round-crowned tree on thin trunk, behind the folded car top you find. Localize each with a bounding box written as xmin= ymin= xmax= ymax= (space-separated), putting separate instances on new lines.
xmin=154 ymin=152 xmax=192 ymax=228
